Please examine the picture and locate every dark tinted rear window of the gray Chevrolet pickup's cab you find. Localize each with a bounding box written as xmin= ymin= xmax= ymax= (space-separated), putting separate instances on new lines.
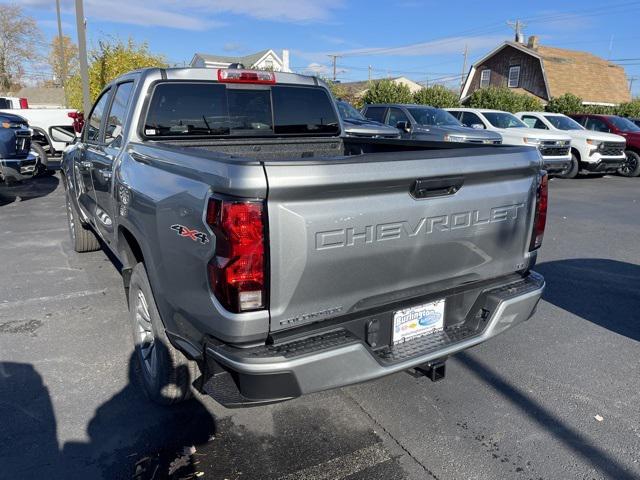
xmin=142 ymin=82 xmax=340 ymax=139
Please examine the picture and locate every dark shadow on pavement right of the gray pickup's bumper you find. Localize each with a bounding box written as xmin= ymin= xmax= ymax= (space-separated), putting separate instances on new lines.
xmin=535 ymin=258 xmax=640 ymax=341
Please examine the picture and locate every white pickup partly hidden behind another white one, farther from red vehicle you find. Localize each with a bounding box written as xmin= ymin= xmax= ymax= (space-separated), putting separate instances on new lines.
xmin=447 ymin=108 xmax=571 ymax=175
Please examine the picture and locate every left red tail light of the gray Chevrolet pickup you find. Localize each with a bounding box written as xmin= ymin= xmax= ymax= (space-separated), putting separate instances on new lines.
xmin=207 ymin=198 xmax=267 ymax=313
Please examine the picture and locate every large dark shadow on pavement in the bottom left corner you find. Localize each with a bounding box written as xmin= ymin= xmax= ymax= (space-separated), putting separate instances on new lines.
xmin=0 ymin=356 xmax=215 ymax=480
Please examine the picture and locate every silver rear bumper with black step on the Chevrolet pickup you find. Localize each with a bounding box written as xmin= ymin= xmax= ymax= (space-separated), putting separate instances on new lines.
xmin=205 ymin=272 xmax=545 ymax=401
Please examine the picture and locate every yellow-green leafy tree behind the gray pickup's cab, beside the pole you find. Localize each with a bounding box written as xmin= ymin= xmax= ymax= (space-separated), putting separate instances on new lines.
xmin=67 ymin=39 xmax=167 ymax=109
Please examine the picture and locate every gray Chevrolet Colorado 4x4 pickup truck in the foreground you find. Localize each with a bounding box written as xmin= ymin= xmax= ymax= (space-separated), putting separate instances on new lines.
xmin=62 ymin=69 xmax=547 ymax=405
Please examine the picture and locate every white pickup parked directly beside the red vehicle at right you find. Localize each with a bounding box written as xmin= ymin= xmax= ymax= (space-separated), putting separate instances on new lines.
xmin=516 ymin=112 xmax=626 ymax=178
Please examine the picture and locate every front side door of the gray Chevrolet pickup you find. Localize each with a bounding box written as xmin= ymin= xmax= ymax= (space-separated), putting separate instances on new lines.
xmin=73 ymin=89 xmax=111 ymax=218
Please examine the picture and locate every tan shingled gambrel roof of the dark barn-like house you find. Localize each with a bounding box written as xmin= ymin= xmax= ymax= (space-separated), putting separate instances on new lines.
xmin=464 ymin=42 xmax=631 ymax=104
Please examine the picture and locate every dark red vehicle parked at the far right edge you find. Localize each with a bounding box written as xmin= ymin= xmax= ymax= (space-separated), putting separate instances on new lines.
xmin=569 ymin=114 xmax=640 ymax=177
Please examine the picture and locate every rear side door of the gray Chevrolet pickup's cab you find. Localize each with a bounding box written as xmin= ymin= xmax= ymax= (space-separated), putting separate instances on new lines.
xmin=91 ymin=81 xmax=133 ymax=243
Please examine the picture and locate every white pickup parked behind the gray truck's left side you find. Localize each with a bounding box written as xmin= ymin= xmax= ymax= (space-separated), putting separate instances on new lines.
xmin=0 ymin=97 xmax=80 ymax=168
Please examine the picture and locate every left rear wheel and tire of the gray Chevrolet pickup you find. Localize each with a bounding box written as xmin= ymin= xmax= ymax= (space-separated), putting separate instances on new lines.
xmin=129 ymin=263 xmax=199 ymax=405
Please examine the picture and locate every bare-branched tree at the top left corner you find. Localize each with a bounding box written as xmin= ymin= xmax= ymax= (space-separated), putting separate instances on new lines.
xmin=0 ymin=4 xmax=42 ymax=90
